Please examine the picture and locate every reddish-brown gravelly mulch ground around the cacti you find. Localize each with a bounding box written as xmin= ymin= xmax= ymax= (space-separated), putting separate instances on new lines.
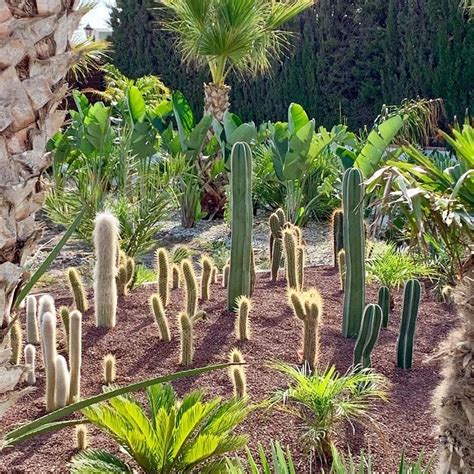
xmin=0 ymin=267 xmax=455 ymax=473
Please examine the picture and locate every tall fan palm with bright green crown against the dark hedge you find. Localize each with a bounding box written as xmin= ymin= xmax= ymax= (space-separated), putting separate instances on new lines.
xmin=161 ymin=0 xmax=314 ymax=121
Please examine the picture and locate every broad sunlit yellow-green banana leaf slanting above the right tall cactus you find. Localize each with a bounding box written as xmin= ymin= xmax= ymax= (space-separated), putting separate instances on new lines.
xmin=354 ymin=115 xmax=404 ymax=178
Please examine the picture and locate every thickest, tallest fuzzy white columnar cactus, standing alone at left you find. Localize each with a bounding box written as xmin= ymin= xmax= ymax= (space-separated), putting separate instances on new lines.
xmin=94 ymin=212 xmax=119 ymax=328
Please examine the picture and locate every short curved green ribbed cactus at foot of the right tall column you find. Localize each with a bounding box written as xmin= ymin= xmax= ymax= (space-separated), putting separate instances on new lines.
xmin=354 ymin=304 xmax=383 ymax=369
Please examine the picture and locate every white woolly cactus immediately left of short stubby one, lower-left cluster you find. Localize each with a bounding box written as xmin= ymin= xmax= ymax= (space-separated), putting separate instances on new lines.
xmin=41 ymin=313 xmax=57 ymax=412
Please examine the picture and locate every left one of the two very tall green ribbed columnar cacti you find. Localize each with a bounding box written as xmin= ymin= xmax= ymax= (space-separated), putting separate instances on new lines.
xmin=227 ymin=143 xmax=253 ymax=311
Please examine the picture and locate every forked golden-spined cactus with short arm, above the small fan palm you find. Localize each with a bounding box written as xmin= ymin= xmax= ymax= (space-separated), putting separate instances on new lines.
xmin=289 ymin=289 xmax=323 ymax=370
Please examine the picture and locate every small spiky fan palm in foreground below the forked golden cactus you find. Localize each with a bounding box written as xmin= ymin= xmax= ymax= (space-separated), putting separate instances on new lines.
xmin=271 ymin=362 xmax=387 ymax=460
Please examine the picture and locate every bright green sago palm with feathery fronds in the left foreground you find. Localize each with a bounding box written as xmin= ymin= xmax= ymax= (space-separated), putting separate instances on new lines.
xmin=71 ymin=384 xmax=249 ymax=474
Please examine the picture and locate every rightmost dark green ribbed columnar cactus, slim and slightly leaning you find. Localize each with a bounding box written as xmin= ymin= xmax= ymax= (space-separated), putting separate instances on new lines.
xmin=397 ymin=280 xmax=421 ymax=369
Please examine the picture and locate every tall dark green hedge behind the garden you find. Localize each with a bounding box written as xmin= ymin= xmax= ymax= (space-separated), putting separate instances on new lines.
xmin=112 ymin=0 xmax=474 ymax=128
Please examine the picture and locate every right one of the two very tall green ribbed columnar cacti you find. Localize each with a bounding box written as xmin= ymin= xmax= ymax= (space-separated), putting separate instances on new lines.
xmin=342 ymin=168 xmax=365 ymax=338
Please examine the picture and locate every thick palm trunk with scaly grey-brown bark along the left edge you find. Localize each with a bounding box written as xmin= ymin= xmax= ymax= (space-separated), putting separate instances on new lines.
xmin=0 ymin=0 xmax=85 ymax=327
